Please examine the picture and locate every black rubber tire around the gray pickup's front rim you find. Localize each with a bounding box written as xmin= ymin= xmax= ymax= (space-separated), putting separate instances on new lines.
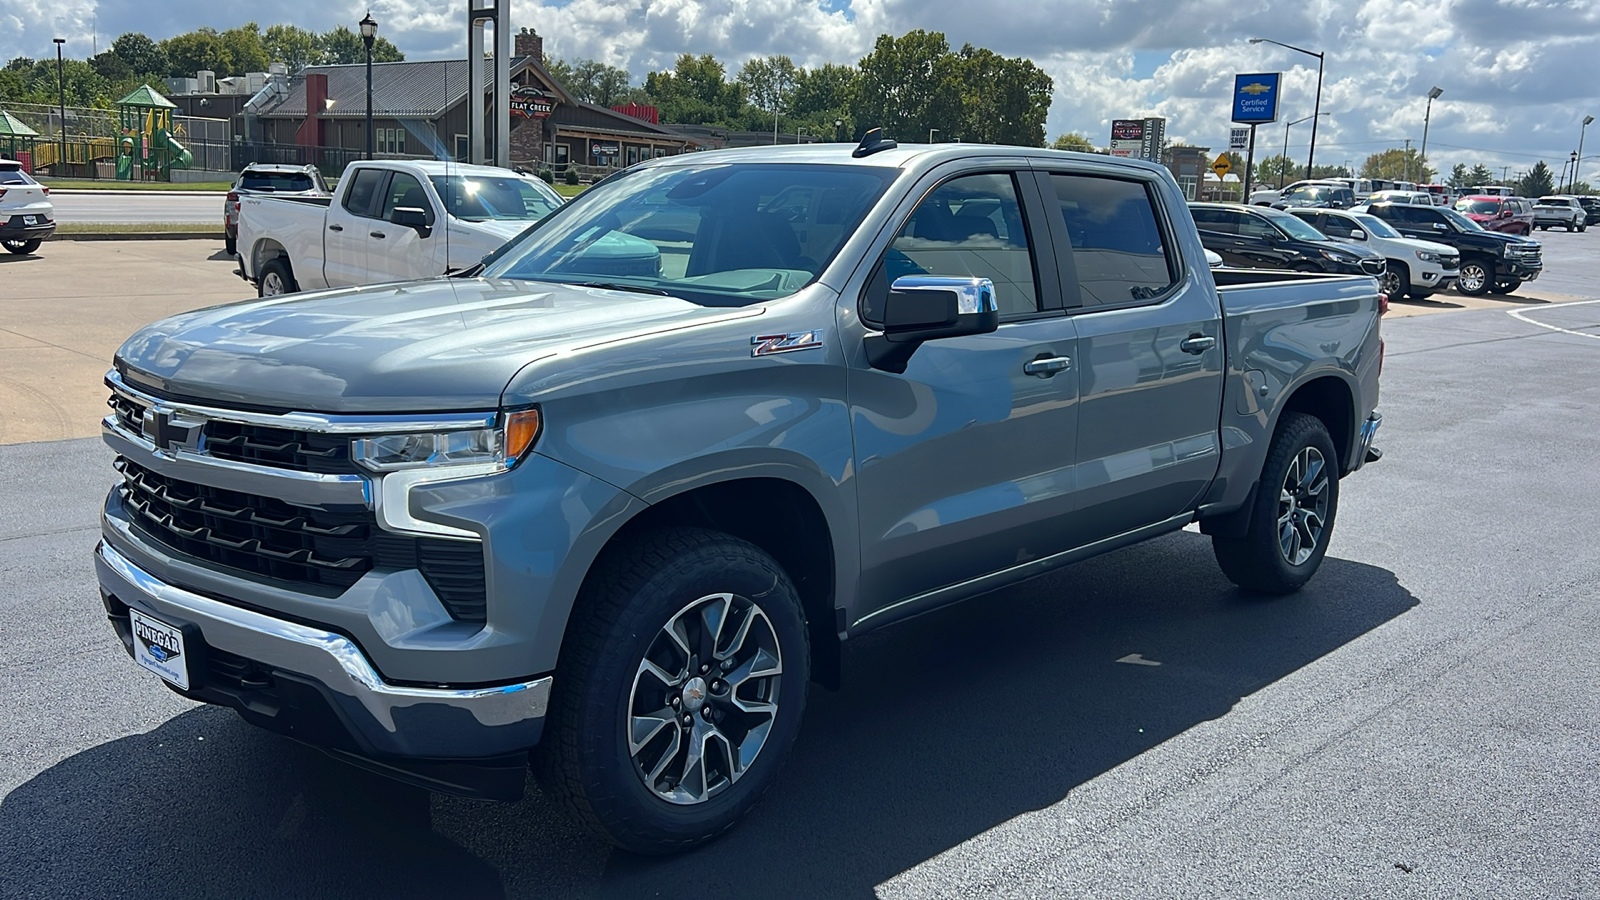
xmin=534 ymin=528 xmax=811 ymax=854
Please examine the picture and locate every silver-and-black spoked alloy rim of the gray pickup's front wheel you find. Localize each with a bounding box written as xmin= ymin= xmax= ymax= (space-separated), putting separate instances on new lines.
xmin=626 ymin=594 xmax=784 ymax=806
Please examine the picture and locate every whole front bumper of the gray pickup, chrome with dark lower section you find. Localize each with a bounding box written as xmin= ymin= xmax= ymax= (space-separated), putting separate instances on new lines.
xmin=94 ymin=531 xmax=552 ymax=799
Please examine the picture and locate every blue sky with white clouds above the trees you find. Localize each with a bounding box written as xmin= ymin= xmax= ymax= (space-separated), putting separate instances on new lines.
xmin=9 ymin=0 xmax=1600 ymax=184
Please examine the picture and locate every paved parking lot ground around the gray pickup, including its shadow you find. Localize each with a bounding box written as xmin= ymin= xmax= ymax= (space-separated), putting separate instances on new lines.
xmin=0 ymin=232 xmax=1600 ymax=898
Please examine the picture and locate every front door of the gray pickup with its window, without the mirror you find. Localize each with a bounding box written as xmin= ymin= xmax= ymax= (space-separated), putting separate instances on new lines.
xmin=850 ymin=166 xmax=1077 ymax=612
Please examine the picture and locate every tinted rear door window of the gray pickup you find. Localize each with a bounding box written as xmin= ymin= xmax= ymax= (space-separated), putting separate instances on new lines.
xmin=1050 ymin=173 xmax=1179 ymax=306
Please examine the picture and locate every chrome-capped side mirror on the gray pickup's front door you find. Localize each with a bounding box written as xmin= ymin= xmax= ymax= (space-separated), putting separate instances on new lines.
xmin=866 ymin=275 xmax=1000 ymax=375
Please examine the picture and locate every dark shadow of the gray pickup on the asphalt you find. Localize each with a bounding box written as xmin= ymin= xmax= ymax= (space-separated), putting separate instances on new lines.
xmin=0 ymin=532 xmax=1418 ymax=898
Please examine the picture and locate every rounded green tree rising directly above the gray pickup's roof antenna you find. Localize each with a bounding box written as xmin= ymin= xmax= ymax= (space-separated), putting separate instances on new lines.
xmin=856 ymin=29 xmax=966 ymax=141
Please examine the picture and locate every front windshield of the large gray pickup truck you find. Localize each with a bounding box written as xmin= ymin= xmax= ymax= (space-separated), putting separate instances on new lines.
xmin=483 ymin=163 xmax=898 ymax=306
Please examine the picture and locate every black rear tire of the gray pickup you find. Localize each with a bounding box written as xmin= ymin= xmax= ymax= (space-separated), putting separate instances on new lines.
xmin=1211 ymin=412 xmax=1339 ymax=596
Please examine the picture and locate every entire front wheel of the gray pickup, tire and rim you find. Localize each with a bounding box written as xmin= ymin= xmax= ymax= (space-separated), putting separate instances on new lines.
xmin=536 ymin=528 xmax=810 ymax=854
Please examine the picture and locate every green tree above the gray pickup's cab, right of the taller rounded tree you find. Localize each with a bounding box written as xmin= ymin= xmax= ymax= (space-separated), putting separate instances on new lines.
xmin=957 ymin=43 xmax=1054 ymax=147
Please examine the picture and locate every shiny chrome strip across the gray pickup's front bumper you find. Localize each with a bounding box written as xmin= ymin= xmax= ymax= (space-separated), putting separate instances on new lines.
xmin=94 ymin=541 xmax=552 ymax=733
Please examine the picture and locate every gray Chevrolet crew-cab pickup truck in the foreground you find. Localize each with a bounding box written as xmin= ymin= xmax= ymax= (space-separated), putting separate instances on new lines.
xmin=94 ymin=136 xmax=1382 ymax=852
